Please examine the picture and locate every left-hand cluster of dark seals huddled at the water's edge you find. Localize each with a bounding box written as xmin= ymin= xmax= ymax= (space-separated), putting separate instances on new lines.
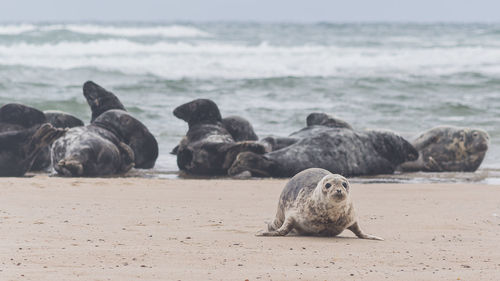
xmin=0 ymin=81 xmax=158 ymax=176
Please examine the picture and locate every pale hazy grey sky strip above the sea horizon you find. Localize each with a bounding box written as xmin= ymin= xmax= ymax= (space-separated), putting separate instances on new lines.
xmin=0 ymin=0 xmax=500 ymax=22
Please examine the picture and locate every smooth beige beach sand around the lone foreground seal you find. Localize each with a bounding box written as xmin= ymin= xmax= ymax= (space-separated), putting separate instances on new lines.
xmin=0 ymin=176 xmax=500 ymax=281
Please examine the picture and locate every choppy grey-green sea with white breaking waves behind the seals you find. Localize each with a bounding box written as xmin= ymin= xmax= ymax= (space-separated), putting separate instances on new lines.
xmin=0 ymin=22 xmax=500 ymax=183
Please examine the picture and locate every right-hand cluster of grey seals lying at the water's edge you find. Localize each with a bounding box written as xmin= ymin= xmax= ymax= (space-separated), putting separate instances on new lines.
xmin=174 ymin=99 xmax=489 ymax=177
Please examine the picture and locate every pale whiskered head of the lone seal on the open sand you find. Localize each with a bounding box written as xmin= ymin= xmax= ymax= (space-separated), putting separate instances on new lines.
xmin=316 ymin=174 xmax=350 ymax=203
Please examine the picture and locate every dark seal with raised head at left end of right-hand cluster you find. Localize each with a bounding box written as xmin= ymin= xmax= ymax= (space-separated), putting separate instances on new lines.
xmin=174 ymin=99 xmax=265 ymax=175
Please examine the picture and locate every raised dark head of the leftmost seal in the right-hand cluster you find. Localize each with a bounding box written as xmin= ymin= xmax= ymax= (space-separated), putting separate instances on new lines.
xmin=174 ymin=99 xmax=222 ymax=127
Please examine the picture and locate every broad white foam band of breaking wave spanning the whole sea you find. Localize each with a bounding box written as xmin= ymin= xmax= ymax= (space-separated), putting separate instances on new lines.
xmin=0 ymin=39 xmax=500 ymax=79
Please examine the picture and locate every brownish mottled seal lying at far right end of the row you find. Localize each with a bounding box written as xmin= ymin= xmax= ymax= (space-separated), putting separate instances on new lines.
xmin=398 ymin=126 xmax=490 ymax=172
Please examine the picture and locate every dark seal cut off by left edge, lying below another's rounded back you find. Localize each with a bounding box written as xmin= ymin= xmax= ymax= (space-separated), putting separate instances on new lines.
xmin=0 ymin=123 xmax=66 ymax=177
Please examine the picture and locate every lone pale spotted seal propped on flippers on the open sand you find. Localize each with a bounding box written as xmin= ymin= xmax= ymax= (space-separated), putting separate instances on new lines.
xmin=258 ymin=168 xmax=383 ymax=240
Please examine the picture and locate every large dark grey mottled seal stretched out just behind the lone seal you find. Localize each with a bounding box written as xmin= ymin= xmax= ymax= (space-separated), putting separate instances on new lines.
xmin=228 ymin=112 xmax=418 ymax=177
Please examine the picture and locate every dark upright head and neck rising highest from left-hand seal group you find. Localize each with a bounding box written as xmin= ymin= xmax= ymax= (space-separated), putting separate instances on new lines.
xmin=83 ymin=81 xmax=126 ymax=122
